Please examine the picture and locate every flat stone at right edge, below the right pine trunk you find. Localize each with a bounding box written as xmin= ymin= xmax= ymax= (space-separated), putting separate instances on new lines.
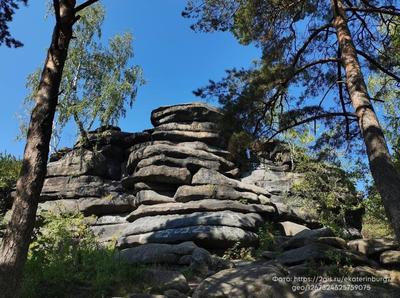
xmin=347 ymin=238 xmax=400 ymax=256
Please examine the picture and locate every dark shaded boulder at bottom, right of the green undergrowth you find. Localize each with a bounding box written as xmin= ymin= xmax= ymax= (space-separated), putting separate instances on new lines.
xmin=142 ymin=269 xmax=190 ymax=293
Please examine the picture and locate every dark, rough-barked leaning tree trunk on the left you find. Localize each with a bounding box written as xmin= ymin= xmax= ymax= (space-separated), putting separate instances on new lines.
xmin=0 ymin=0 xmax=76 ymax=298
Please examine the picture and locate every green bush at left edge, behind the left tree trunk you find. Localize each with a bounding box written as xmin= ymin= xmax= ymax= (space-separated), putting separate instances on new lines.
xmin=0 ymin=153 xmax=21 ymax=214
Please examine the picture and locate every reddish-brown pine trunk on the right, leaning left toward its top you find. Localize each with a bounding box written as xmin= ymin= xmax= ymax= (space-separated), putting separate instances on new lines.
xmin=331 ymin=0 xmax=400 ymax=239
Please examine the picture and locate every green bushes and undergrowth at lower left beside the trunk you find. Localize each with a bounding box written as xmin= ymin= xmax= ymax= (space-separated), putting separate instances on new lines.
xmin=23 ymin=213 xmax=142 ymax=297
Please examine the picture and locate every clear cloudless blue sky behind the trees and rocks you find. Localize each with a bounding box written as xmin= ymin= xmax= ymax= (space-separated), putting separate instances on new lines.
xmin=0 ymin=0 xmax=259 ymax=156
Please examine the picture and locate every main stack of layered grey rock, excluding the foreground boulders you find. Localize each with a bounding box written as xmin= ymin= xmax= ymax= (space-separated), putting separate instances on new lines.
xmin=40 ymin=103 xmax=316 ymax=249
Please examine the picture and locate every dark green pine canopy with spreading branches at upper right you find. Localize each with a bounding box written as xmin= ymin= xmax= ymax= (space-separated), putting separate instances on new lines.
xmin=183 ymin=0 xmax=400 ymax=159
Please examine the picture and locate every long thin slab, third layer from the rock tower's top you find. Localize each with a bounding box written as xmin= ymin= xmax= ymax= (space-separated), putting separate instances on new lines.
xmin=151 ymin=130 xmax=224 ymax=146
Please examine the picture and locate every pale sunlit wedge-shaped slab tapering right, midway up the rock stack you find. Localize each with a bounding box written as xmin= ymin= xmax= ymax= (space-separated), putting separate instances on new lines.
xmin=192 ymin=168 xmax=270 ymax=197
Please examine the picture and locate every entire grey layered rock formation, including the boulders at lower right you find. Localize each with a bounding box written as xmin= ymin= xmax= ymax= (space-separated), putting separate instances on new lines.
xmin=39 ymin=103 xmax=400 ymax=297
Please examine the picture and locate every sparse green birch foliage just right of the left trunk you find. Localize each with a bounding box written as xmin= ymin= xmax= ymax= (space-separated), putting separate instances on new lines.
xmin=22 ymin=4 xmax=144 ymax=147
